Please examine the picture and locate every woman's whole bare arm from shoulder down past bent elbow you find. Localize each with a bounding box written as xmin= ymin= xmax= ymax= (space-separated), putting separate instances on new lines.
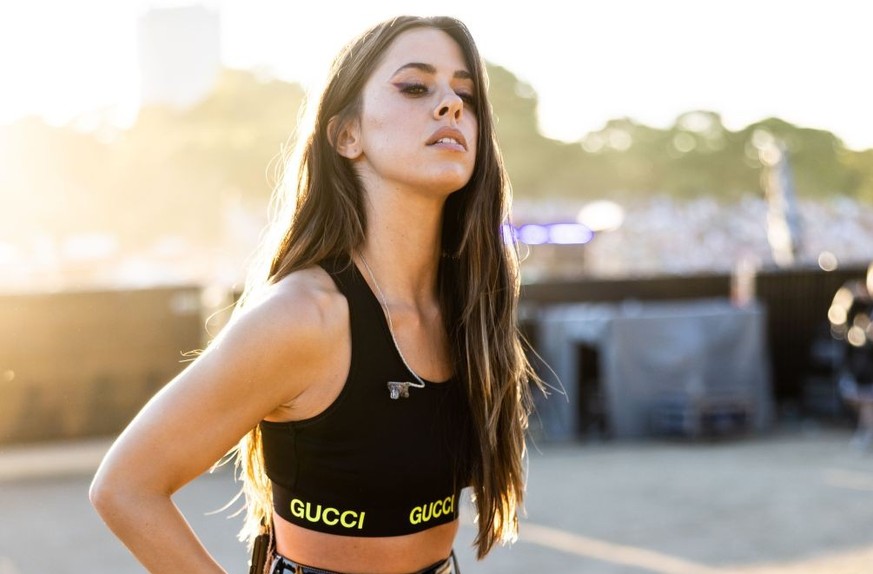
xmin=90 ymin=271 xmax=348 ymax=573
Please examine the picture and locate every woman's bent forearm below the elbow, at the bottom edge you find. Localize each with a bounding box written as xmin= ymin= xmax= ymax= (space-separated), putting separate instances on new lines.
xmin=91 ymin=484 xmax=224 ymax=574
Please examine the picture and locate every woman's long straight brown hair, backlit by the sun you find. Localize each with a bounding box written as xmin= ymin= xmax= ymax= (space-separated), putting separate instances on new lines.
xmin=235 ymin=16 xmax=539 ymax=558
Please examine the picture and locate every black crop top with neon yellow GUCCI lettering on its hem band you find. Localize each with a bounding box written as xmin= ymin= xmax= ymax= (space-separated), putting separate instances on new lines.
xmin=260 ymin=259 xmax=470 ymax=536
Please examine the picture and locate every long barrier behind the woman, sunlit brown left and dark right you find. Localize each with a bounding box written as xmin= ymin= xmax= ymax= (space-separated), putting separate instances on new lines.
xmin=0 ymin=267 xmax=865 ymax=443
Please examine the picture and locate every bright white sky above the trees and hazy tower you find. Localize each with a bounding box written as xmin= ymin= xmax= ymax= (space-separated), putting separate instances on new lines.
xmin=0 ymin=0 xmax=873 ymax=149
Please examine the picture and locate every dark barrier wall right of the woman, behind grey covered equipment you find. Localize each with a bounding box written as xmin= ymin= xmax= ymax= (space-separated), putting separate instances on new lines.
xmin=522 ymin=267 xmax=866 ymax=412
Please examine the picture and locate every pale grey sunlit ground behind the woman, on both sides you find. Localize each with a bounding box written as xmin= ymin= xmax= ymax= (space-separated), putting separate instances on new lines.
xmin=0 ymin=425 xmax=873 ymax=574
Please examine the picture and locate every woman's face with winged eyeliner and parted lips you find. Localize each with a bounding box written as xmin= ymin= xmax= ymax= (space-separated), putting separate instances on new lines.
xmin=341 ymin=28 xmax=478 ymax=202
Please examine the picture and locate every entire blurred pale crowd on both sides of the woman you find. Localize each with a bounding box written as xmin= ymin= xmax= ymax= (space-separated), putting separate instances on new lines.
xmin=0 ymin=195 xmax=873 ymax=292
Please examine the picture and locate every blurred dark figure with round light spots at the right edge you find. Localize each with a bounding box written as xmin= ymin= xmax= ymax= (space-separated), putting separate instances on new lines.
xmin=828 ymin=263 xmax=873 ymax=450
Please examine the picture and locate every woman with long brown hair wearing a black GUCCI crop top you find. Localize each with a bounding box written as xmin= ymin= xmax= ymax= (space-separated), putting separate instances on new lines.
xmin=91 ymin=17 xmax=538 ymax=573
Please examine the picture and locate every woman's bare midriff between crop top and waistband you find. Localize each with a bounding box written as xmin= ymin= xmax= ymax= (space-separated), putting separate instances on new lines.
xmin=273 ymin=514 xmax=458 ymax=574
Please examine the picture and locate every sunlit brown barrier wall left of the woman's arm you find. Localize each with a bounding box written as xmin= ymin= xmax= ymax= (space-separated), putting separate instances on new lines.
xmin=0 ymin=287 xmax=204 ymax=443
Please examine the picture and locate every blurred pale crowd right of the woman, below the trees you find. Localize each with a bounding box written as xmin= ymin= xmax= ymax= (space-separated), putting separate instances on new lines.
xmin=514 ymin=196 xmax=873 ymax=281
